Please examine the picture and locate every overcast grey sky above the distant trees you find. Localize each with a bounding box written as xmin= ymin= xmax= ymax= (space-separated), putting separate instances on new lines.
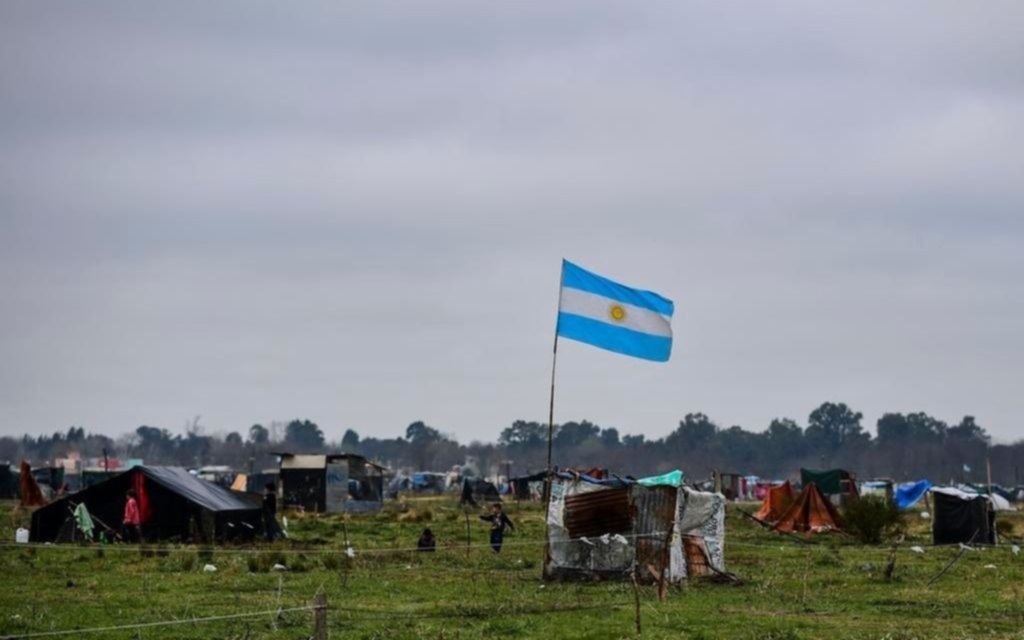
xmin=0 ymin=0 xmax=1024 ymax=441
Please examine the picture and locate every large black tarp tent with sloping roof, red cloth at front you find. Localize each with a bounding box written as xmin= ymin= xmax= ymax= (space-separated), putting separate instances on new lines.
xmin=30 ymin=467 xmax=276 ymax=543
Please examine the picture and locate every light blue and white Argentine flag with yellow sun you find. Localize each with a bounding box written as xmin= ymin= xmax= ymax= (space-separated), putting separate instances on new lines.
xmin=556 ymin=260 xmax=675 ymax=362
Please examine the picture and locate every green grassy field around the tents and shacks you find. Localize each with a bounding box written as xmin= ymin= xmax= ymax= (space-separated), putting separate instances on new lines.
xmin=0 ymin=499 xmax=1024 ymax=640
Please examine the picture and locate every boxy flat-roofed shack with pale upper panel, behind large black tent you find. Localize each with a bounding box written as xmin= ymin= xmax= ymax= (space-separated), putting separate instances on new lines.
xmin=274 ymin=453 xmax=387 ymax=513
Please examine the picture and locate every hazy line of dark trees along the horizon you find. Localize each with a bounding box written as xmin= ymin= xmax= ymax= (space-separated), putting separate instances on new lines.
xmin=0 ymin=402 xmax=1024 ymax=485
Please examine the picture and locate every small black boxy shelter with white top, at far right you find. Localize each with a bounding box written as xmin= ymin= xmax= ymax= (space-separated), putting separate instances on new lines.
xmin=932 ymin=486 xmax=995 ymax=545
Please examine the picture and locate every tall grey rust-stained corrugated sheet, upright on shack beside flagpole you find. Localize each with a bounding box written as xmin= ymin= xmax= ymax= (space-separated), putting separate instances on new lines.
xmin=630 ymin=485 xmax=678 ymax=582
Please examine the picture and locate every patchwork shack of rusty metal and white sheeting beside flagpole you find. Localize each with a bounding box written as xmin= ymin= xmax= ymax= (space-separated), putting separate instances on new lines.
xmin=544 ymin=472 xmax=725 ymax=583
